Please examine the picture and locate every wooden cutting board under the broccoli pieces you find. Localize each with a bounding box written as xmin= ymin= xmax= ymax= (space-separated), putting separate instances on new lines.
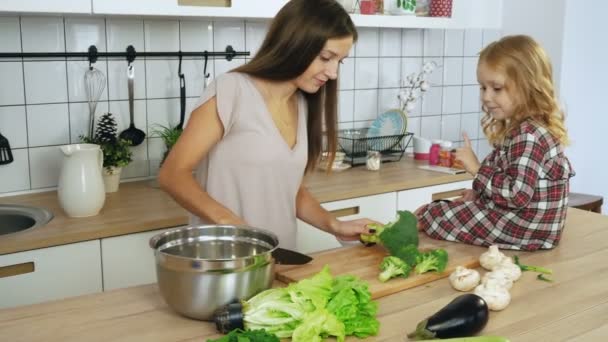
xmin=276 ymin=236 xmax=485 ymax=299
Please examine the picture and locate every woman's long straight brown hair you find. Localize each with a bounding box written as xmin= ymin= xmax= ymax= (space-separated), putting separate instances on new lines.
xmin=234 ymin=0 xmax=357 ymax=172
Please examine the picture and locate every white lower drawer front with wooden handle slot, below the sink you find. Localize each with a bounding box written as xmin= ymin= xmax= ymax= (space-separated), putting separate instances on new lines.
xmin=0 ymin=240 xmax=102 ymax=308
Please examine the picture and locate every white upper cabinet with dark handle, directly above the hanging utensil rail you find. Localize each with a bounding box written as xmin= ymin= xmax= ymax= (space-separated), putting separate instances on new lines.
xmin=92 ymin=0 xmax=287 ymax=19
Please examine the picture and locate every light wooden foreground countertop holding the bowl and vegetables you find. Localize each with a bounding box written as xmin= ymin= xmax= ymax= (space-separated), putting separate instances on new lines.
xmin=0 ymin=208 xmax=608 ymax=342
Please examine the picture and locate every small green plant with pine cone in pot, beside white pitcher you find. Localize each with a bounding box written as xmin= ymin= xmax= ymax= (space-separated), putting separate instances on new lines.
xmin=80 ymin=113 xmax=133 ymax=192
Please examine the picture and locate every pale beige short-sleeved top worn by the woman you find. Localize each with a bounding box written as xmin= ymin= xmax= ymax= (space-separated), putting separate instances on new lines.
xmin=191 ymin=72 xmax=308 ymax=249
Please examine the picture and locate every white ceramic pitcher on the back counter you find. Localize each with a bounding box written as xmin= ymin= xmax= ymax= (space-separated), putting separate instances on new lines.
xmin=57 ymin=144 xmax=106 ymax=217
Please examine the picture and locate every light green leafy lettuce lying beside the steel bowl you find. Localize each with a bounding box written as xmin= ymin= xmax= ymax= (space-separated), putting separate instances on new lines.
xmin=239 ymin=266 xmax=379 ymax=342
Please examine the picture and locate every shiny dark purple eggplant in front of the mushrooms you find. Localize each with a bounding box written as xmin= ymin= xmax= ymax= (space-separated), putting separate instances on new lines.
xmin=407 ymin=293 xmax=489 ymax=340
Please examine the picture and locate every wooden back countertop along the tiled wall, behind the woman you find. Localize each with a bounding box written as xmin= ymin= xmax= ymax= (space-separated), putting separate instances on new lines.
xmin=0 ymin=157 xmax=471 ymax=255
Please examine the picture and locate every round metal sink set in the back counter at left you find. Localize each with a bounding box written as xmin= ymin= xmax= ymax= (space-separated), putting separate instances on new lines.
xmin=0 ymin=204 xmax=53 ymax=235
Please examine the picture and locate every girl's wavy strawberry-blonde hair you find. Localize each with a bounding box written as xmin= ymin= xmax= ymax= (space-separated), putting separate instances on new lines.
xmin=478 ymin=35 xmax=568 ymax=146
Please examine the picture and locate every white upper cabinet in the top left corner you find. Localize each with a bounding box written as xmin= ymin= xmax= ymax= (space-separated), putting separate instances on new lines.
xmin=0 ymin=0 xmax=91 ymax=14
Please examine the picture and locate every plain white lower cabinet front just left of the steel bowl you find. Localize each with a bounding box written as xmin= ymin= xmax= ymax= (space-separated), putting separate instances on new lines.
xmin=101 ymin=227 xmax=177 ymax=291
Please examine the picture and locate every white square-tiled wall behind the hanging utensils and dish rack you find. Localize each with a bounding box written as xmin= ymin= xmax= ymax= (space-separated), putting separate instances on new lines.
xmin=0 ymin=16 xmax=500 ymax=194
